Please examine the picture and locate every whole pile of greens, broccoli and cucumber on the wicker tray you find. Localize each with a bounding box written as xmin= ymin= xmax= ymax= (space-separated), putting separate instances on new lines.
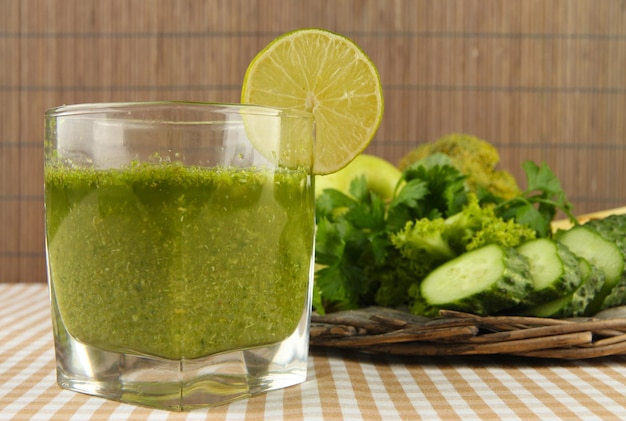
xmin=313 ymin=134 xmax=626 ymax=317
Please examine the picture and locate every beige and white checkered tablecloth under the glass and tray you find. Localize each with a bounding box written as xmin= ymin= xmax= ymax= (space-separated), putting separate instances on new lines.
xmin=0 ymin=284 xmax=626 ymax=420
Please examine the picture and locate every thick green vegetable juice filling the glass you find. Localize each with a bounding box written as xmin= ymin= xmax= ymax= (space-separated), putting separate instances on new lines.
xmin=45 ymin=164 xmax=314 ymax=359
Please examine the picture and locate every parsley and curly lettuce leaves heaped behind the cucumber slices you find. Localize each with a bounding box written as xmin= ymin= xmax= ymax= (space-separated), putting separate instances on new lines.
xmin=314 ymin=138 xmax=572 ymax=314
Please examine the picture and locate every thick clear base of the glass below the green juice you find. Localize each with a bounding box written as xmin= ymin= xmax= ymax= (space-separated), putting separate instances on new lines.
xmin=55 ymin=324 xmax=308 ymax=411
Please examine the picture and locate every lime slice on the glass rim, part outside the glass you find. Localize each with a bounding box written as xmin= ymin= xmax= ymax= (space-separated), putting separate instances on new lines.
xmin=241 ymin=29 xmax=383 ymax=174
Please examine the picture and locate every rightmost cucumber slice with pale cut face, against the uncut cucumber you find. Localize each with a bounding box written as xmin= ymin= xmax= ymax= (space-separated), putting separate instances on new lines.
xmin=557 ymin=225 xmax=624 ymax=314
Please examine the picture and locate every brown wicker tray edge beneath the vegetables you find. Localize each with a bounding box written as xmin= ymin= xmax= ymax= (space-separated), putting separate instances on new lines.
xmin=310 ymin=307 xmax=626 ymax=359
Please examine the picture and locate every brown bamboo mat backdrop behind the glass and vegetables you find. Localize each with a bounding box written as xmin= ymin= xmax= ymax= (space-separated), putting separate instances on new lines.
xmin=0 ymin=0 xmax=626 ymax=282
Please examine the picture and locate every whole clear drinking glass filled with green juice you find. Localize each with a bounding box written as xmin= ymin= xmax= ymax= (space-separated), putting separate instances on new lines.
xmin=44 ymin=102 xmax=315 ymax=410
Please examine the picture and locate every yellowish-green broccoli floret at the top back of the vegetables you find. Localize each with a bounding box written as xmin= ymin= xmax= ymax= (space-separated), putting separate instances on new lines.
xmin=398 ymin=133 xmax=521 ymax=199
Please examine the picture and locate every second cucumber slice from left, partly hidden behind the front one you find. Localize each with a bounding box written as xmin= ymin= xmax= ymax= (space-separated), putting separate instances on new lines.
xmin=517 ymin=238 xmax=581 ymax=306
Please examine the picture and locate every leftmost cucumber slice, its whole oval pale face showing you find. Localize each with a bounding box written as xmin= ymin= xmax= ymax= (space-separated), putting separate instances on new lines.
xmin=420 ymin=244 xmax=534 ymax=315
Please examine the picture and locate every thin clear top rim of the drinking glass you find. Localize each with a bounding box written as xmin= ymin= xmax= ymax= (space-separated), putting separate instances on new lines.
xmin=44 ymin=101 xmax=314 ymax=120
